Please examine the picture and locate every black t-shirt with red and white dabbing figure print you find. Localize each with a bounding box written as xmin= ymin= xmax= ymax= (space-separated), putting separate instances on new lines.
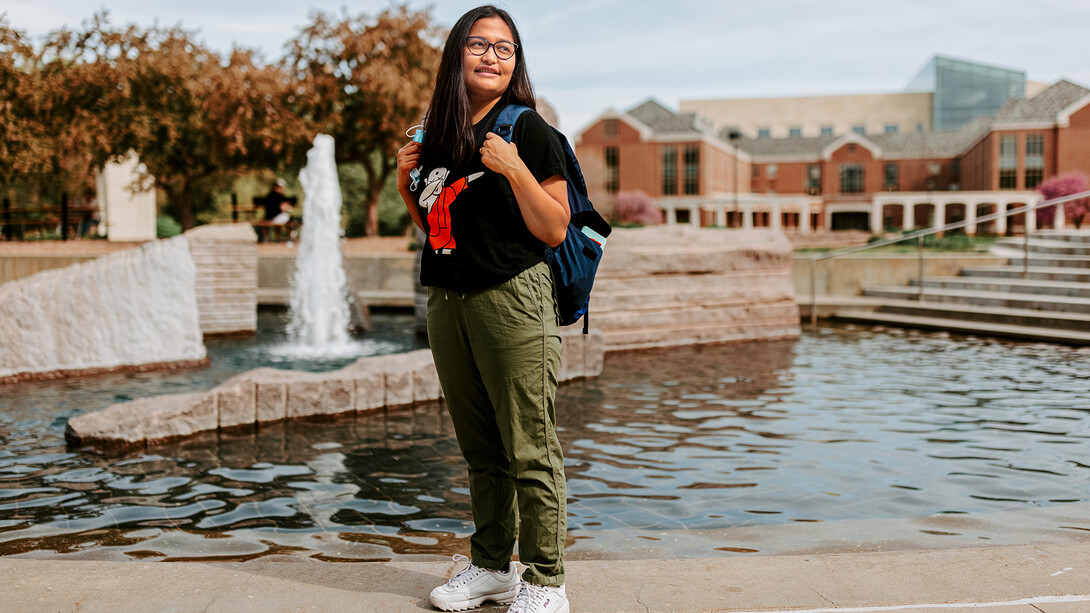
xmin=413 ymin=104 xmax=565 ymax=290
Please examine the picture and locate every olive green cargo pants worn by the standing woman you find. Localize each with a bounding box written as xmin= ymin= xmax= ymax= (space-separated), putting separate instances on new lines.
xmin=427 ymin=263 xmax=567 ymax=586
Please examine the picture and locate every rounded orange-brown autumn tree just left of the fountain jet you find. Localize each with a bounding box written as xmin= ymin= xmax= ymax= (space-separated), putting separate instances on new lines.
xmin=128 ymin=27 xmax=308 ymax=229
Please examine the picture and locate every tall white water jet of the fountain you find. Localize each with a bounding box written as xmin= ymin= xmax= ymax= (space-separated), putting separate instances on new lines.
xmin=288 ymin=134 xmax=360 ymax=357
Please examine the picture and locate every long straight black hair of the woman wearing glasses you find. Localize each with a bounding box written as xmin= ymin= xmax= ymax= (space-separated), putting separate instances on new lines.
xmin=424 ymin=4 xmax=537 ymax=164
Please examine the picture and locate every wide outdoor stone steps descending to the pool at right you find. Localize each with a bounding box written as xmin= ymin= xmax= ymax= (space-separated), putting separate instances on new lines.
xmin=834 ymin=231 xmax=1090 ymax=345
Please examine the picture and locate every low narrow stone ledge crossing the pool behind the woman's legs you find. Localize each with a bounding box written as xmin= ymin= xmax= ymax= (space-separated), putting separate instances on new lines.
xmin=65 ymin=330 xmax=604 ymax=447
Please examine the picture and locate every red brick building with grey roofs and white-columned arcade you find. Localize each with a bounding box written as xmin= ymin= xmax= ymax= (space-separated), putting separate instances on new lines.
xmin=576 ymin=81 xmax=1090 ymax=233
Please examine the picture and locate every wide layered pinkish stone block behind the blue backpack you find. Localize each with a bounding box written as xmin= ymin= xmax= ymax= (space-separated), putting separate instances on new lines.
xmin=590 ymin=226 xmax=800 ymax=352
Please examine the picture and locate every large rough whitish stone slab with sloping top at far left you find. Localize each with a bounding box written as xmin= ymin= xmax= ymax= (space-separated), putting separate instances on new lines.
xmin=0 ymin=237 xmax=207 ymax=382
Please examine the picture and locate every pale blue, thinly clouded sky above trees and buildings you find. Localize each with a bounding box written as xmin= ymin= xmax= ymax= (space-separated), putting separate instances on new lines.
xmin=6 ymin=0 xmax=1090 ymax=137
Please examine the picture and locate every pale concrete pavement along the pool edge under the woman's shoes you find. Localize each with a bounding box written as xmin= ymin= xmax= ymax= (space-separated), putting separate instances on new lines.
xmin=0 ymin=543 xmax=1090 ymax=613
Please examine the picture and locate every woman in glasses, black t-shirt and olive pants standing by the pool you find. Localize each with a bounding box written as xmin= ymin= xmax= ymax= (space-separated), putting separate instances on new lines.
xmin=398 ymin=5 xmax=570 ymax=613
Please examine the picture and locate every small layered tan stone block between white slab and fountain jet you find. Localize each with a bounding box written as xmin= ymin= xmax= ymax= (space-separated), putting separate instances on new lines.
xmin=185 ymin=224 xmax=257 ymax=335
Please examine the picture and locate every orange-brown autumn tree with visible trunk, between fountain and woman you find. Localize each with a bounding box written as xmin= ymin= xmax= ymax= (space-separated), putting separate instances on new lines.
xmin=284 ymin=5 xmax=440 ymax=236
